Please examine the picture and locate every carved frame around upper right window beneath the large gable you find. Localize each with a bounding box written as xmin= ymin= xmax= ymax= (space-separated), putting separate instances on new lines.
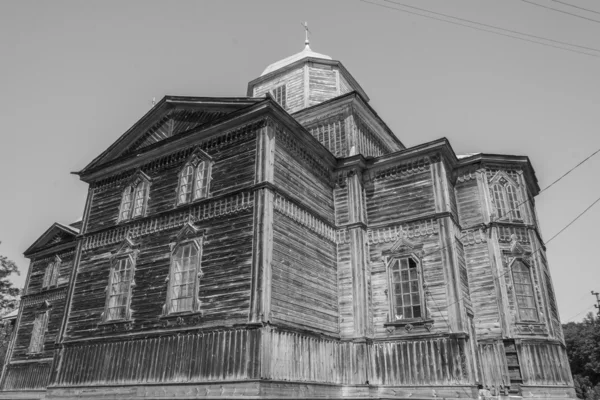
xmin=175 ymin=150 xmax=213 ymax=206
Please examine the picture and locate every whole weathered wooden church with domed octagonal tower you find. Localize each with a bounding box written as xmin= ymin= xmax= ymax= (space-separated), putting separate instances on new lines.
xmin=0 ymin=41 xmax=575 ymax=399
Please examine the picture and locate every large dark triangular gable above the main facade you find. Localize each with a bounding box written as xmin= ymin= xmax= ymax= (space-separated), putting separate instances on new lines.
xmin=78 ymin=96 xmax=261 ymax=175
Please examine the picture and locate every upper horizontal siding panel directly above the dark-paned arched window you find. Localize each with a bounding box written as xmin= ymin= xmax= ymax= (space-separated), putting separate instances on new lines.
xmin=367 ymin=161 xmax=435 ymax=224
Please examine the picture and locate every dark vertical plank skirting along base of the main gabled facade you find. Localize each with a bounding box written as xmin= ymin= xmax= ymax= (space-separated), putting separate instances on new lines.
xmin=51 ymin=329 xmax=261 ymax=386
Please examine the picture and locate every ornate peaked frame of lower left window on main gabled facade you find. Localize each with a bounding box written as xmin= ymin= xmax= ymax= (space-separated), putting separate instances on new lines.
xmin=101 ymin=239 xmax=139 ymax=324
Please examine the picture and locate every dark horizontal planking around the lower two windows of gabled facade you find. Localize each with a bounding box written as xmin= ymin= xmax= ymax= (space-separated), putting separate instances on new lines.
xmin=67 ymin=209 xmax=252 ymax=338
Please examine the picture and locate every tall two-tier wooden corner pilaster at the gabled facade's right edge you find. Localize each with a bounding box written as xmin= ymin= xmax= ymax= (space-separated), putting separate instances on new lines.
xmin=248 ymin=120 xmax=275 ymax=322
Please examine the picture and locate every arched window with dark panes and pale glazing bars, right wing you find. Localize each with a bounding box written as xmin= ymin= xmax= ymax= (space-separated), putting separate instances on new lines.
xmin=390 ymin=257 xmax=424 ymax=320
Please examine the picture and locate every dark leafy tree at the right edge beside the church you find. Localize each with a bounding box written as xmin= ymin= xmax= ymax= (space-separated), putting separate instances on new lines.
xmin=563 ymin=313 xmax=600 ymax=400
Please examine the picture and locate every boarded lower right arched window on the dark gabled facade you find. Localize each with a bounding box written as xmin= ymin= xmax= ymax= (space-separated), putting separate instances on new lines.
xmin=167 ymin=243 xmax=200 ymax=313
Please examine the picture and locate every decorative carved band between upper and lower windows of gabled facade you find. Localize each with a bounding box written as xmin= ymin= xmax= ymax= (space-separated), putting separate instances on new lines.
xmin=83 ymin=192 xmax=254 ymax=251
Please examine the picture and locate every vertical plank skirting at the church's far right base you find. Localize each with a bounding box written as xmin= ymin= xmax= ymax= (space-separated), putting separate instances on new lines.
xmin=517 ymin=340 xmax=573 ymax=386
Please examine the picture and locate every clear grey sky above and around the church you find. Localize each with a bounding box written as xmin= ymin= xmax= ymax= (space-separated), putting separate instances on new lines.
xmin=0 ymin=0 xmax=600 ymax=322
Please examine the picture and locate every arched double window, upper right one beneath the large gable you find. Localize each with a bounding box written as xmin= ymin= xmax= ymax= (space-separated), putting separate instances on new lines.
xmin=177 ymin=152 xmax=211 ymax=205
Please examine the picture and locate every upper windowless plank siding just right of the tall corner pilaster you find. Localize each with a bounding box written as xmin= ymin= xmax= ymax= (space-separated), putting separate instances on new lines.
xmin=274 ymin=135 xmax=334 ymax=223
